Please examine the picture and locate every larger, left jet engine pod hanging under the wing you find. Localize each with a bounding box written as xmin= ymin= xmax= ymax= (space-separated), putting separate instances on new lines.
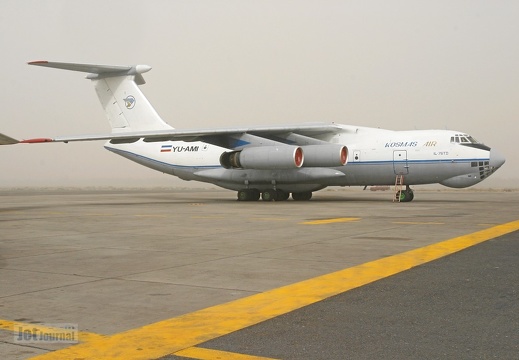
xmin=220 ymin=145 xmax=304 ymax=170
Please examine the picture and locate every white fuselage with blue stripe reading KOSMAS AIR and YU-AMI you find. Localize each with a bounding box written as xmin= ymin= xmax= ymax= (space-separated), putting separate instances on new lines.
xmin=105 ymin=125 xmax=504 ymax=192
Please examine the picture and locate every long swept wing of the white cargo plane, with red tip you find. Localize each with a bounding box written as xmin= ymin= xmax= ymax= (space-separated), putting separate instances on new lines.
xmin=0 ymin=123 xmax=350 ymax=148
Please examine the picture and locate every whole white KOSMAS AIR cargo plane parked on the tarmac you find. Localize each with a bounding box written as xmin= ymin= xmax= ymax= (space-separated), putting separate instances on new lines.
xmin=0 ymin=61 xmax=505 ymax=202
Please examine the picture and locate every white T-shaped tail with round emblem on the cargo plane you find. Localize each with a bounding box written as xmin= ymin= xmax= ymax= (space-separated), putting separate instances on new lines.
xmin=29 ymin=61 xmax=172 ymax=133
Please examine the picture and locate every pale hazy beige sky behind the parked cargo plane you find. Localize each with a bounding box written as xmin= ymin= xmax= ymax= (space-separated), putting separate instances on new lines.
xmin=0 ymin=0 xmax=519 ymax=187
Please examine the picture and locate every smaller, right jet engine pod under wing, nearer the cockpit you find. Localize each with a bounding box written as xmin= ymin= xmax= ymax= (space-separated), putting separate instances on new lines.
xmin=303 ymin=144 xmax=348 ymax=167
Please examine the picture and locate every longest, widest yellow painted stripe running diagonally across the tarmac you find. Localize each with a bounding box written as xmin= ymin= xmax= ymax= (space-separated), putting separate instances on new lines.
xmin=29 ymin=220 xmax=519 ymax=359
